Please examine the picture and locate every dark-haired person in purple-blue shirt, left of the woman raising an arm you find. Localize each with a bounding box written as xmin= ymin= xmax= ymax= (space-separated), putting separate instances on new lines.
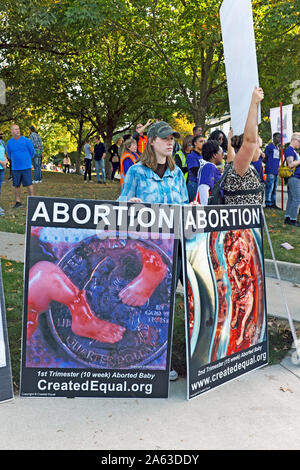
xmin=198 ymin=140 xmax=223 ymax=206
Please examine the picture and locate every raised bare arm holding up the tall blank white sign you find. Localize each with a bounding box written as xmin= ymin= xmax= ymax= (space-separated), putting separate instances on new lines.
xmin=233 ymin=87 xmax=264 ymax=176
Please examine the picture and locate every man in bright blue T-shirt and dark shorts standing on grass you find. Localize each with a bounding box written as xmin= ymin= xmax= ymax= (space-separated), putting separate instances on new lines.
xmin=6 ymin=124 xmax=35 ymax=209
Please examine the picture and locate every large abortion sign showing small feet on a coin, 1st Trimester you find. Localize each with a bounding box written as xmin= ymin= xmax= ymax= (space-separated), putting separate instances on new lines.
xmin=21 ymin=197 xmax=180 ymax=398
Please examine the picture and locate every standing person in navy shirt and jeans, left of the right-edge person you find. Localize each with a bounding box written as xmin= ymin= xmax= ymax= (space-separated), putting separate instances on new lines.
xmin=265 ymin=132 xmax=281 ymax=209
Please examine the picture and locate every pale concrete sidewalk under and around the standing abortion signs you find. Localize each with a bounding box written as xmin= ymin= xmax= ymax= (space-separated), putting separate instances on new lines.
xmin=0 ymin=233 xmax=300 ymax=451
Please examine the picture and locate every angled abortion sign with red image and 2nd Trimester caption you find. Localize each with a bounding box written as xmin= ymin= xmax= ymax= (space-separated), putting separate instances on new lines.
xmin=182 ymin=206 xmax=268 ymax=399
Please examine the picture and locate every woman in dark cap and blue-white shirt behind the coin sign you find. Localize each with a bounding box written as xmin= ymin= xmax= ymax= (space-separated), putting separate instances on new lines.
xmin=118 ymin=121 xmax=189 ymax=204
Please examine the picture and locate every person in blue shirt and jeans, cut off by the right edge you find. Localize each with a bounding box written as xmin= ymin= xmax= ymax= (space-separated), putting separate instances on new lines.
xmin=284 ymin=132 xmax=300 ymax=227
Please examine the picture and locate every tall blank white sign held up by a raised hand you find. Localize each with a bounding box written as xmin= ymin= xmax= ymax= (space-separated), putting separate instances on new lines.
xmin=220 ymin=0 xmax=261 ymax=135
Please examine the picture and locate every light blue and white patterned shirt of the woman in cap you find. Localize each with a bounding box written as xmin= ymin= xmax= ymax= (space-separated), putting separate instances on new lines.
xmin=118 ymin=162 xmax=189 ymax=204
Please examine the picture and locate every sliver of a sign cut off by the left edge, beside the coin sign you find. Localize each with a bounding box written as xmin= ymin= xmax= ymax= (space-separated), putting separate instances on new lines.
xmin=0 ymin=264 xmax=13 ymax=402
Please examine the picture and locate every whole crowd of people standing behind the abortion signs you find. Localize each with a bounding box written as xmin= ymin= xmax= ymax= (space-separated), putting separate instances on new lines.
xmin=0 ymin=88 xmax=300 ymax=227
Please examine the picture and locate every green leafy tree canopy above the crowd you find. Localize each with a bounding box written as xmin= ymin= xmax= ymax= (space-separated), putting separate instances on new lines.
xmin=0 ymin=0 xmax=300 ymax=167
